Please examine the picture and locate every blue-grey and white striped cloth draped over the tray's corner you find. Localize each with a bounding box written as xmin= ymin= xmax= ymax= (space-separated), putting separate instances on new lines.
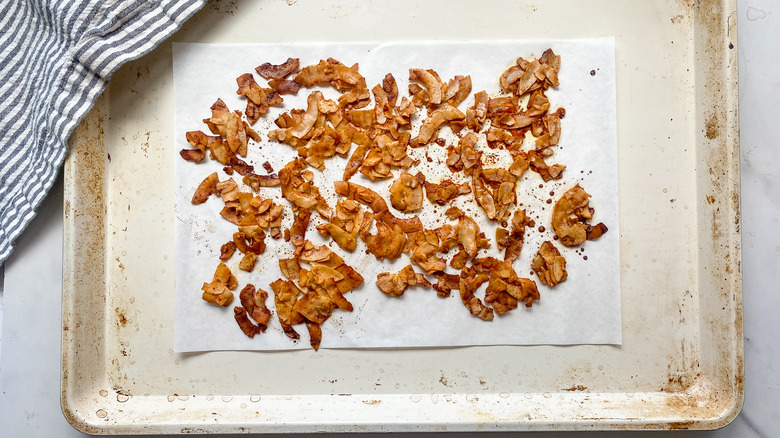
xmin=0 ymin=0 xmax=205 ymax=266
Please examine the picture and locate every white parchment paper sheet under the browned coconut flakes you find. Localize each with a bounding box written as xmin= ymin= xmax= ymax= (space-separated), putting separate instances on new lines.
xmin=171 ymin=38 xmax=621 ymax=352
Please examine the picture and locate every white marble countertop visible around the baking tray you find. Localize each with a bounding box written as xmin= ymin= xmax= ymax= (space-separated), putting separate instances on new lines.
xmin=0 ymin=0 xmax=780 ymax=438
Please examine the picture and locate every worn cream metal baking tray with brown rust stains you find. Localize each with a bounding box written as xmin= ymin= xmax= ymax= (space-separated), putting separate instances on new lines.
xmin=62 ymin=0 xmax=743 ymax=434
